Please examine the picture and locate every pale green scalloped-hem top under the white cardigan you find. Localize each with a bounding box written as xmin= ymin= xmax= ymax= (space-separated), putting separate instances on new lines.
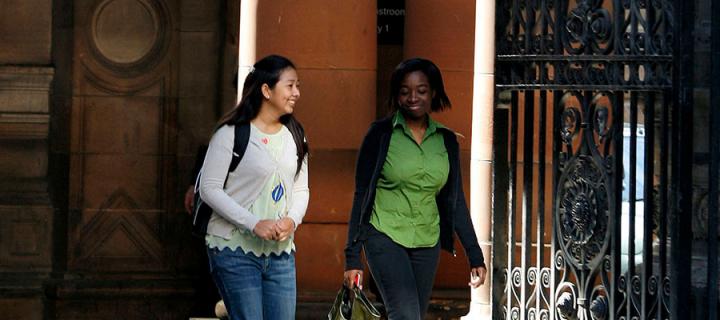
xmin=205 ymin=126 xmax=295 ymax=257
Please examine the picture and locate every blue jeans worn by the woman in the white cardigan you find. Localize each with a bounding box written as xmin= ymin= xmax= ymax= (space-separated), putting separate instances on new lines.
xmin=208 ymin=248 xmax=297 ymax=320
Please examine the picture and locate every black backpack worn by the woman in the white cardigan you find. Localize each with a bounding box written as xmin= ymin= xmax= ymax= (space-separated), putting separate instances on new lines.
xmin=192 ymin=123 xmax=250 ymax=238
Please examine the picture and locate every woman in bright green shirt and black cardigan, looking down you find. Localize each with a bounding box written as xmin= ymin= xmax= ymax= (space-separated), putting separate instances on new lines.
xmin=344 ymin=58 xmax=486 ymax=320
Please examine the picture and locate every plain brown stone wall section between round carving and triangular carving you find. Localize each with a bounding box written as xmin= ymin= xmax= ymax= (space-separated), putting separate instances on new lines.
xmin=70 ymin=97 xmax=167 ymax=212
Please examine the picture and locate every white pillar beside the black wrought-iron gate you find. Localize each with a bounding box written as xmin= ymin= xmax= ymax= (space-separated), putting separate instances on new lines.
xmin=462 ymin=0 xmax=495 ymax=320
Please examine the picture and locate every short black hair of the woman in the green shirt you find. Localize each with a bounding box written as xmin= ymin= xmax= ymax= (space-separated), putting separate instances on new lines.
xmin=388 ymin=58 xmax=451 ymax=112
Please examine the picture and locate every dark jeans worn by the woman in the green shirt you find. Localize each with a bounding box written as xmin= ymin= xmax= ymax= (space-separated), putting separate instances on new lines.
xmin=363 ymin=227 xmax=440 ymax=320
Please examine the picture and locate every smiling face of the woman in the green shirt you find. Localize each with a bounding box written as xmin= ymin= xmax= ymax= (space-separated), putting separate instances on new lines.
xmin=397 ymin=71 xmax=435 ymax=120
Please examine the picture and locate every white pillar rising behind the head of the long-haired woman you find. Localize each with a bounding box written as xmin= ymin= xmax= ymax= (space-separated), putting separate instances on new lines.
xmin=235 ymin=0 xmax=258 ymax=104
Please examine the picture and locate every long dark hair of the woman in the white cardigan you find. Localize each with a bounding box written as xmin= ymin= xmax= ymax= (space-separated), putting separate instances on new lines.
xmin=217 ymin=55 xmax=310 ymax=175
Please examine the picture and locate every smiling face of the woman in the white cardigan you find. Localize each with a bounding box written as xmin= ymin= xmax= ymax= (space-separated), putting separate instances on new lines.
xmin=263 ymin=68 xmax=300 ymax=116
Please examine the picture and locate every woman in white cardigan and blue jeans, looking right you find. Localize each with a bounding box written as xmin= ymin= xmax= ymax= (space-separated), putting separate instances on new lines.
xmin=200 ymin=55 xmax=309 ymax=320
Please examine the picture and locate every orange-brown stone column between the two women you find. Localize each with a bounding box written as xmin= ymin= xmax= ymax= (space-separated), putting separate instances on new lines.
xmin=256 ymin=0 xmax=377 ymax=294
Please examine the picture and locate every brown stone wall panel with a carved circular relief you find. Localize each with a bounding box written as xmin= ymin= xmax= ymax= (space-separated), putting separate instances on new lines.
xmin=74 ymin=0 xmax=176 ymax=95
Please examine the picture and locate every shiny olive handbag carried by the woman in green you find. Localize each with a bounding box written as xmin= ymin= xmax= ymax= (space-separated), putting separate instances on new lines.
xmin=328 ymin=284 xmax=380 ymax=320
